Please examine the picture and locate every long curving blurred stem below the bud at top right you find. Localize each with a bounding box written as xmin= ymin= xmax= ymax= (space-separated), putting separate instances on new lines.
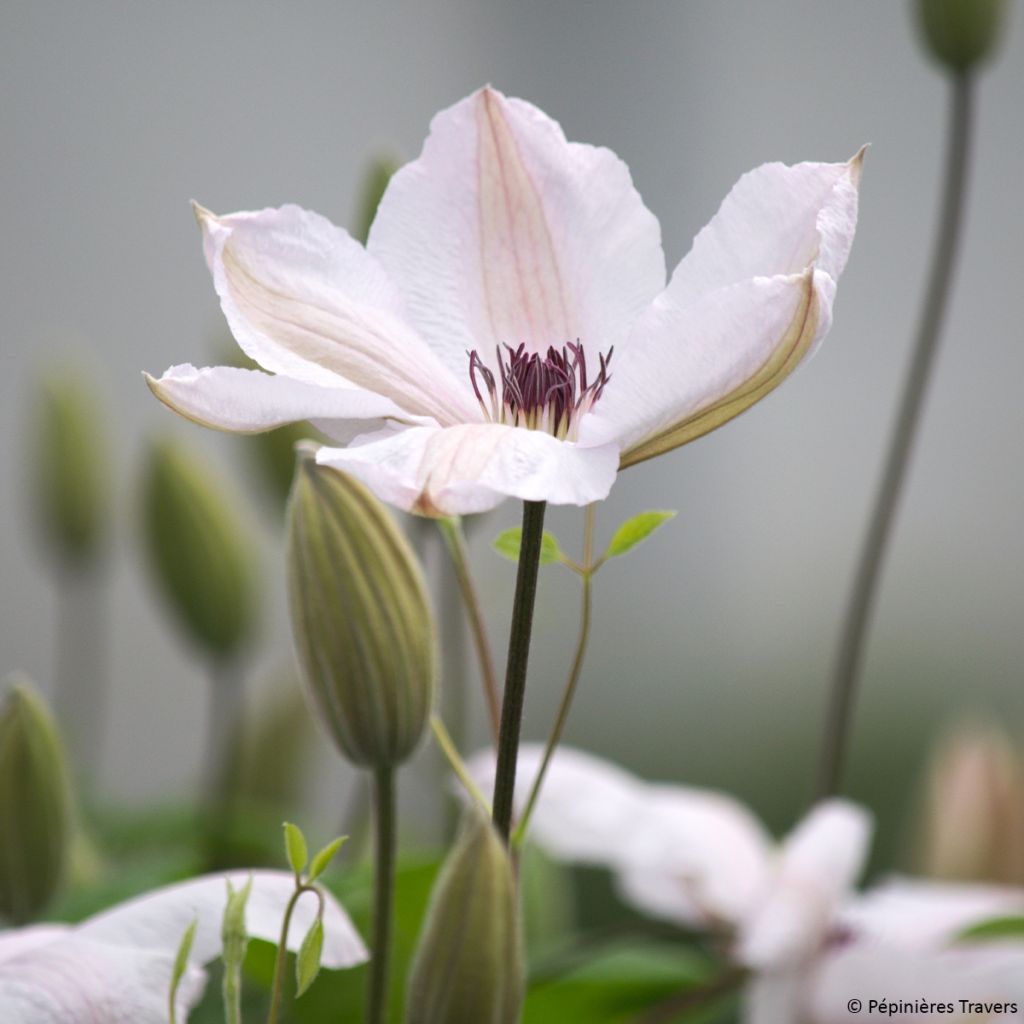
xmin=818 ymin=73 xmax=973 ymax=798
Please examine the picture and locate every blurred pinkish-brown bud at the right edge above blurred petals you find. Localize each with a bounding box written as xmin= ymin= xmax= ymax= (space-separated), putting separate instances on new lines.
xmin=921 ymin=723 xmax=1024 ymax=885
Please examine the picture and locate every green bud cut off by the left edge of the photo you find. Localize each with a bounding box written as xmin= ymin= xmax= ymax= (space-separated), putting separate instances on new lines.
xmin=0 ymin=679 xmax=72 ymax=925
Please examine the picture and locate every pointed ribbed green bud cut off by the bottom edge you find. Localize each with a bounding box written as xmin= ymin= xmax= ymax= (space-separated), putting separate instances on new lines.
xmin=406 ymin=808 xmax=524 ymax=1024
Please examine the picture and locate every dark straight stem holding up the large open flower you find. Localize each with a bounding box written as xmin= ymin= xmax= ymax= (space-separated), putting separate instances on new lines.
xmin=494 ymin=502 xmax=545 ymax=842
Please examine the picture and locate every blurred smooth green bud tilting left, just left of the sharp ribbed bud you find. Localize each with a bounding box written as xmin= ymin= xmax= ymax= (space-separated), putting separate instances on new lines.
xmin=143 ymin=439 xmax=257 ymax=658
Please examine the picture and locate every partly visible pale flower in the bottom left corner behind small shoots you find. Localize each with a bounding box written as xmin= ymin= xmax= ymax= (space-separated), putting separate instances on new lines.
xmin=0 ymin=871 xmax=368 ymax=1024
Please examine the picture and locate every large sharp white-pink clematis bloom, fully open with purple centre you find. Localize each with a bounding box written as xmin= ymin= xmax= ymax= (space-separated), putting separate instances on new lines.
xmin=147 ymin=88 xmax=861 ymax=515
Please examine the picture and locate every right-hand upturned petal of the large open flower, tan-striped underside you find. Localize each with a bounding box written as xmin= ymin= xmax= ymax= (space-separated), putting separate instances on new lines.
xmin=581 ymin=158 xmax=860 ymax=467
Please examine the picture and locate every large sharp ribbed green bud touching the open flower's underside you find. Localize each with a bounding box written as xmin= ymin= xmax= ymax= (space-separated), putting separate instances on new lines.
xmin=288 ymin=455 xmax=437 ymax=767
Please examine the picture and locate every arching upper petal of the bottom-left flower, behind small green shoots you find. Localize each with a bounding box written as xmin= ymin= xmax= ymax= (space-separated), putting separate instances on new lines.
xmin=76 ymin=870 xmax=368 ymax=968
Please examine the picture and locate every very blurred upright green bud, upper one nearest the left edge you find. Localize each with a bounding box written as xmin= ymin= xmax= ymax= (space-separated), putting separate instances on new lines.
xmin=32 ymin=371 xmax=111 ymax=565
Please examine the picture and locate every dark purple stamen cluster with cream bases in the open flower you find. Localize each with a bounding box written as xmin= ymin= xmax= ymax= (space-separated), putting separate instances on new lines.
xmin=467 ymin=342 xmax=614 ymax=440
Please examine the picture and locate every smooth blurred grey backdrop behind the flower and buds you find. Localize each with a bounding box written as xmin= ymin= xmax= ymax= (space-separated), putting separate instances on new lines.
xmin=0 ymin=0 xmax=1024 ymax=854
